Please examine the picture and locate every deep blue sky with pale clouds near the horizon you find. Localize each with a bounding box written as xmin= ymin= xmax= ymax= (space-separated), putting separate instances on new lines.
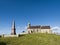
xmin=0 ymin=0 xmax=60 ymax=34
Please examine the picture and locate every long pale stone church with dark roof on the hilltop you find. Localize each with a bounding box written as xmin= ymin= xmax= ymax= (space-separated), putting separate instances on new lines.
xmin=27 ymin=23 xmax=51 ymax=33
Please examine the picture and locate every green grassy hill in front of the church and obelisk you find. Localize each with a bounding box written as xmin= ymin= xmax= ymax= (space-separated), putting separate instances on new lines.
xmin=0 ymin=33 xmax=60 ymax=45
